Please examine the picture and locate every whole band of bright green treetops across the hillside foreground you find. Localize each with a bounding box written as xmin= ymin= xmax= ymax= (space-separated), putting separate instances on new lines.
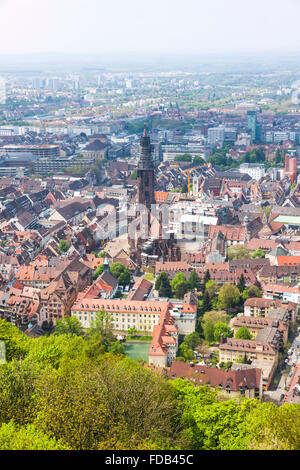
xmin=0 ymin=321 xmax=300 ymax=450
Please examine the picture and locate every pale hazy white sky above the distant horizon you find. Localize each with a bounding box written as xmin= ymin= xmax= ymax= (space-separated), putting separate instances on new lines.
xmin=0 ymin=0 xmax=300 ymax=54
